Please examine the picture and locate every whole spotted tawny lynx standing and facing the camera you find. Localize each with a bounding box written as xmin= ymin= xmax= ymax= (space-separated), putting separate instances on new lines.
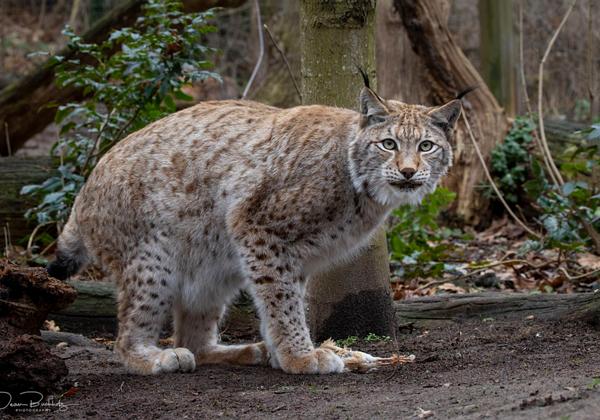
xmin=48 ymin=81 xmax=461 ymax=374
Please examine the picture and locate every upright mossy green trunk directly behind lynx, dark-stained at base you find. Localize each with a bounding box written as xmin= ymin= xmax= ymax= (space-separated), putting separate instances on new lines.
xmin=301 ymin=0 xmax=395 ymax=340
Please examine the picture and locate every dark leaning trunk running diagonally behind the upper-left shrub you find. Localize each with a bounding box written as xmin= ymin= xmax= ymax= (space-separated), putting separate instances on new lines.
xmin=0 ymin=0 xmax=245 ymax=156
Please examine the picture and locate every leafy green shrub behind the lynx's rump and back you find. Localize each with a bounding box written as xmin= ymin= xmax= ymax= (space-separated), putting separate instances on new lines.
xmin=21 ymin=0 xmax=219 ymax=228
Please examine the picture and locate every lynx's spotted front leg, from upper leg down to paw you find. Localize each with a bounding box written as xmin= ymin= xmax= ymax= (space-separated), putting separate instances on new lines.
xmin=228 ymin=213 xmax=344 ymax=374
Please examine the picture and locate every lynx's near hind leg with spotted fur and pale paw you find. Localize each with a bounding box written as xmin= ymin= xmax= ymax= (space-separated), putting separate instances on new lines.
xmin=115 ymin=265 xmax=196 ymax=375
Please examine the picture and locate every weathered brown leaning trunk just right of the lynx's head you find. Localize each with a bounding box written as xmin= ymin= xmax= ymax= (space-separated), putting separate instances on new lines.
xmin=394 ymin=0 xmax=507 ymax=225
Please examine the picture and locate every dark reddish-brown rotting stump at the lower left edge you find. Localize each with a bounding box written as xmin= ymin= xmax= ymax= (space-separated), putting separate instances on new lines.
xmin=0 ymin=260 xmax=77 ymax=396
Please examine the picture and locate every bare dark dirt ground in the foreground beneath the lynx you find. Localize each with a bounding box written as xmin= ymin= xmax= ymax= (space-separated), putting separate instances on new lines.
xmin=11 ymin=320 xmax=600 ymax=419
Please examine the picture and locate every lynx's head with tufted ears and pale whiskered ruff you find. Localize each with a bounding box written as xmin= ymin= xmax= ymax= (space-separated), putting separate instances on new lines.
xmin=349 ymin=85 xmax=461 ymax=206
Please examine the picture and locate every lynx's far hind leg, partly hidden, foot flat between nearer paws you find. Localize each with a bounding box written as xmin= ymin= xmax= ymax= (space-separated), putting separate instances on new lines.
xmin=175 ymin=307 xmax=269 ymax=365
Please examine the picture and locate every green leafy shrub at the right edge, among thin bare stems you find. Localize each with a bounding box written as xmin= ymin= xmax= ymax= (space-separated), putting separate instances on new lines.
xmin=487 ymin=117 xmax=600 ymax=252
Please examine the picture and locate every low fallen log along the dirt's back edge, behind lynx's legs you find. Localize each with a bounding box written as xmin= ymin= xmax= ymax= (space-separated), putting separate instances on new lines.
xmin=52 ymin=281 xmax=600 ymax=333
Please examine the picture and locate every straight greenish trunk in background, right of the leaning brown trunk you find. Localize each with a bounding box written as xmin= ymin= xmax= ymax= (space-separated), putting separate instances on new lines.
xmin=479 ymin=0 xmax=518 ymax=117
